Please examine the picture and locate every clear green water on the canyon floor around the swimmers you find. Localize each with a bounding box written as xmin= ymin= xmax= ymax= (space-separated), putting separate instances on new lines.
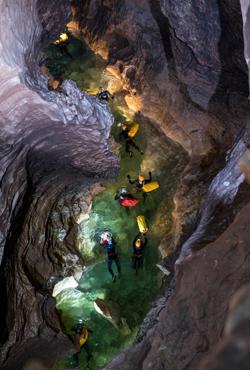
xmin=47 ymin=32 xmax=186 ymax=370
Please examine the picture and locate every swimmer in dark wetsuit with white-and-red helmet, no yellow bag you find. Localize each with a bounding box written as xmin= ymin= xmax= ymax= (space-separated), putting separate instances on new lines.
xmin=100 ymin=231 xmax=121 ymax=282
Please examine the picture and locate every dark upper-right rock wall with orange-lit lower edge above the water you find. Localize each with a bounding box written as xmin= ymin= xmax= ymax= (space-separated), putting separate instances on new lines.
xmin=69 ymin=0 xmax=248 ymax=164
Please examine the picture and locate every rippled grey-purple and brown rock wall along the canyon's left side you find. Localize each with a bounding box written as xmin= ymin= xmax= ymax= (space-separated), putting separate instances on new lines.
xmin=0 ymin=0 xmax=118 ymax=370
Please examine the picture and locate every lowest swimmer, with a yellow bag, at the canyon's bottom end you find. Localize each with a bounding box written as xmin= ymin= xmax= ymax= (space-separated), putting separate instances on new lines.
xmin=70 ymin=319 xmax=93 ymax=367
